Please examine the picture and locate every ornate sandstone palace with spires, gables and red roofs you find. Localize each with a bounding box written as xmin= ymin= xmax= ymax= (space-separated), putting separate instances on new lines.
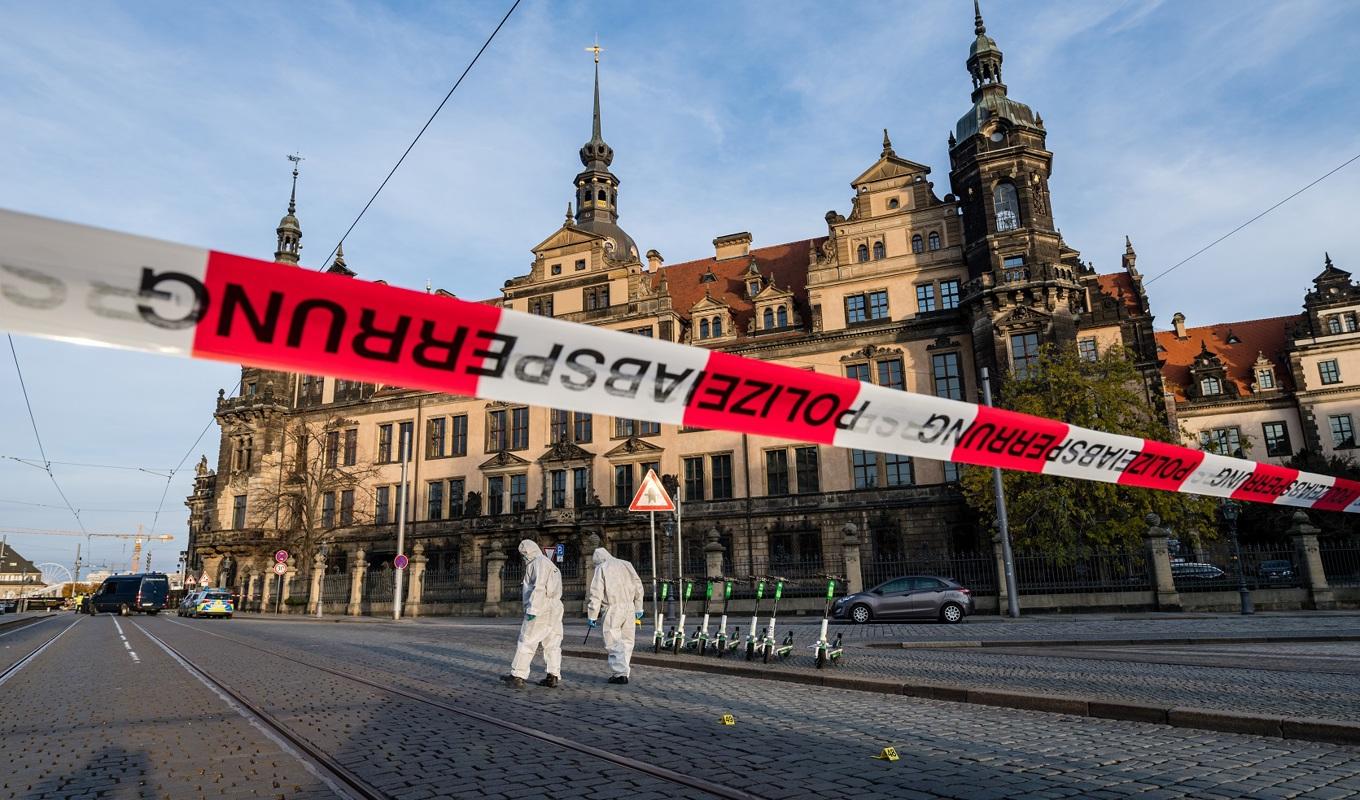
xmin=186 ymin=4 xmax=1360 ymax=612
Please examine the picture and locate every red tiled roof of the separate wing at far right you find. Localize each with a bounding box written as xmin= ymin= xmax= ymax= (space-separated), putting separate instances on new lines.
xmin=1153 ymin=312 xmax=1299 ymax=401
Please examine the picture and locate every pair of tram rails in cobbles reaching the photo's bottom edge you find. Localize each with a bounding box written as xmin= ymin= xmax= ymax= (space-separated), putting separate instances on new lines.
xmin=148 ymin=619 xmax=764 ymax=800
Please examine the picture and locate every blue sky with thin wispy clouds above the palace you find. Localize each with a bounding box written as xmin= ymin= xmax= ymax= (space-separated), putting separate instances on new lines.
xmin=0 ymin=0 xmax=1360 ymax=570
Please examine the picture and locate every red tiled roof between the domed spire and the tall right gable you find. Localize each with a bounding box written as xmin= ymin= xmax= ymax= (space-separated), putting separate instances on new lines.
xmin=651 ymin=237 xmax=827 ymax=335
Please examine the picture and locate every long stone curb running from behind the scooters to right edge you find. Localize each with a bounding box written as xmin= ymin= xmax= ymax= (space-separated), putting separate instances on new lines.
xmin=562 ymin=647 xmax=1360 ymax=744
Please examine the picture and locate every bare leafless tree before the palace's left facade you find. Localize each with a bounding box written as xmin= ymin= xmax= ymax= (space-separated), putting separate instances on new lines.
xmin=256 ymin=418 xmax=378 ymax=570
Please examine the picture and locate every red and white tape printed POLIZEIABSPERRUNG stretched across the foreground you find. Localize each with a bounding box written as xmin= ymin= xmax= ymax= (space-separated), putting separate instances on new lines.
xmin=0 ymin=211 xmax=1360 ymax=512
